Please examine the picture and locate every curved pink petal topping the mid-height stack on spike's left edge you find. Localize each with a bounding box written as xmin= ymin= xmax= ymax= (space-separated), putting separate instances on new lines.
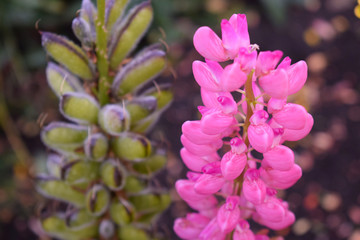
xmin=182 ymin=120 xmax=222 ymax=145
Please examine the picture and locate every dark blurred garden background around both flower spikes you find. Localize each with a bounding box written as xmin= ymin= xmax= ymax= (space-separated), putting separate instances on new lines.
xmin=0 ymin=0 xmax=360 ymax=240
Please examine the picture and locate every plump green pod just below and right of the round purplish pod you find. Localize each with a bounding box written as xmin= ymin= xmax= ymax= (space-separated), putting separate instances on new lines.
xmin=111 ymin=133 xmax=151 ymax=161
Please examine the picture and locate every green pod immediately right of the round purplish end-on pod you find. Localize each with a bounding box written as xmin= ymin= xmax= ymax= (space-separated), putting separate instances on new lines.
xmin=126 ymin=96 xmax=157 ymax=127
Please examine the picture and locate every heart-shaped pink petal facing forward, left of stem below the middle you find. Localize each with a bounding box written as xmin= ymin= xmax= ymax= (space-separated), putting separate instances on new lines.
xmin=221 ymin=151 xmax=247 ymax=180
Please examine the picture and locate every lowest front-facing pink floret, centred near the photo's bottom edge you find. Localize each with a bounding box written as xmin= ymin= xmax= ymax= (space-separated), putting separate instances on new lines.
xmin=217 ymin=196 xmax=240 ymax=233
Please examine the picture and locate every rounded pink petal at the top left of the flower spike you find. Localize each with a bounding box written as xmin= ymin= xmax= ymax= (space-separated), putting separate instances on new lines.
xmin=194 ymin=27 xmax=228 ymax=62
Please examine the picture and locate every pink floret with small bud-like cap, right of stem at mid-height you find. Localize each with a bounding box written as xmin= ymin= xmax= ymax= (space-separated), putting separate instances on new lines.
xmin=248 ymin=110 xmax=274 ymax=153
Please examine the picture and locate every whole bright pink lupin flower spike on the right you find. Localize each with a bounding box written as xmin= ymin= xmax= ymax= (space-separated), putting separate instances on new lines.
xmin=174 ymin=14 xmax=314 ymax=240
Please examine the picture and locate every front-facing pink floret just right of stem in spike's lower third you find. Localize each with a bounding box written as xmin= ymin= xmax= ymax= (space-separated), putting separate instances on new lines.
xmin=243 ymin=169 xmax=266 ymax=205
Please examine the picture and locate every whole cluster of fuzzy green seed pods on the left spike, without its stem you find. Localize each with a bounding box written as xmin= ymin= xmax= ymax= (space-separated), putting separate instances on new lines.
xmin=37 ymin=0 xmax=173 ymax=240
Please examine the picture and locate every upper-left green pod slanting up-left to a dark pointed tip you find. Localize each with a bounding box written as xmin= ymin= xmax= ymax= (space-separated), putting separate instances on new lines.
xmin=41 ymin=32 xmax=94 ymax=80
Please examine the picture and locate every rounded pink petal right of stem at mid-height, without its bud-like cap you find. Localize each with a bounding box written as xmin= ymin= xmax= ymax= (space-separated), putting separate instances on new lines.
xmin=248 ymin=123 xmax=274 ymax=153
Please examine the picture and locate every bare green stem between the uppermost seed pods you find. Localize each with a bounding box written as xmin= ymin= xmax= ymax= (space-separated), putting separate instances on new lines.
xmin=95 ymin=0 xmax=111 ymax=105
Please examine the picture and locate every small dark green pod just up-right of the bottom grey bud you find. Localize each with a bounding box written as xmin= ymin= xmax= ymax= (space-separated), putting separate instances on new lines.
xmin=109 ymin=199 xmax=135 ymax=226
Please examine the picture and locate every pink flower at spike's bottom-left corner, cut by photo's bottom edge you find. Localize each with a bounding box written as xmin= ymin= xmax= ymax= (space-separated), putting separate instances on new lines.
xmin=174 ymin=213 xmax=211 ymax=240
